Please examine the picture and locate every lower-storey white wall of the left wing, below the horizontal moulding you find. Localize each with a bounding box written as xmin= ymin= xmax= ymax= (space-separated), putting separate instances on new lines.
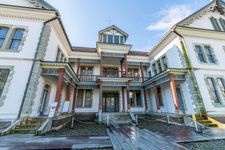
xmin=0 ymin=59 xmax=32 ymax=119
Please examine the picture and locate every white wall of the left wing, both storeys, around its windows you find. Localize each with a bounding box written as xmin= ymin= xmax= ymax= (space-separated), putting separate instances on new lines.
xmin=0 ymin=18 xmax=43 ymax=119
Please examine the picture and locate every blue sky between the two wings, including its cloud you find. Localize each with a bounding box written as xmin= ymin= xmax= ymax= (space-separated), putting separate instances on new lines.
xmin=46 ymin=0 xmax=210 ymax=51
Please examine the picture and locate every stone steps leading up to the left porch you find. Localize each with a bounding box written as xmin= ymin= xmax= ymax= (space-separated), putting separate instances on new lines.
xmin=10 ymin=117 xmax=46 ymax=134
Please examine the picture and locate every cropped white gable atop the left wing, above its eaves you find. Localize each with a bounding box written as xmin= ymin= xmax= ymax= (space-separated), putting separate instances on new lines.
xmin=0 ymin=0 xmax=55 ymax=10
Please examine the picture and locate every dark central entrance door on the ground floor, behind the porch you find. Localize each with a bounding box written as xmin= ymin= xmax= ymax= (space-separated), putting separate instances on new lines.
xmin=102 ymin=93 xmax=119 ymax=112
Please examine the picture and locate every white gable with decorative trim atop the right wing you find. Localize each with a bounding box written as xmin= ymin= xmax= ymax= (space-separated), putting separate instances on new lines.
xmin=177 ymin=0 xmax=225 ymax=30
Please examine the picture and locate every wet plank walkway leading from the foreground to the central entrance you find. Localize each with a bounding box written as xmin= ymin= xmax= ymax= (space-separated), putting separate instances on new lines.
xmin=107 ymin=124 xmax=186 ymax=150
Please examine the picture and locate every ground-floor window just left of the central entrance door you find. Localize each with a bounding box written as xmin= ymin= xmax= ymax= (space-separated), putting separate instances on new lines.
xmin=76 ymin=89 xmax=93 ymax=108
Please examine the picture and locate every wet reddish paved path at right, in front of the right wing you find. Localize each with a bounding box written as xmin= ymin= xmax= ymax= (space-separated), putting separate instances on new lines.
xmin=155 ymin=127 xmax=225 ymax=143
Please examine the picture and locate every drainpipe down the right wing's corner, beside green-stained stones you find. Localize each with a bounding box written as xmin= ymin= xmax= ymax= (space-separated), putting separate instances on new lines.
xmin=172 ymin=27 xmax=206 ymax=116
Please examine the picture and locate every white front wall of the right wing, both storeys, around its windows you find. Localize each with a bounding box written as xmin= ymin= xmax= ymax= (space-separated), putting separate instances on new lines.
xmin=185 ymin=37 xmax=225 ymax=114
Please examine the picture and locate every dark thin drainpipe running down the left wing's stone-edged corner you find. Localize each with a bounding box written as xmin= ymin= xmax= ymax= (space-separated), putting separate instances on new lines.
xmin=17 ymin=13 xmax=59 ymax=120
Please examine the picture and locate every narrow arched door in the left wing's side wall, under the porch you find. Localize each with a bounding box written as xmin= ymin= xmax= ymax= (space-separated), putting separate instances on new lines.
xmin=40 ymin=85 xmax=50 ymax=116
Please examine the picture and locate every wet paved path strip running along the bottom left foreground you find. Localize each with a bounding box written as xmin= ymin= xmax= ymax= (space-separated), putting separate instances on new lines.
xmin=0 ymin=134 xmax=112 ymax=150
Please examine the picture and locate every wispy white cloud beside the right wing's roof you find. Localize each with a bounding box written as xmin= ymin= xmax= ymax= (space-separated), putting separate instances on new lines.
xmin=147 ymin=4 xmax=192 ymax=31
